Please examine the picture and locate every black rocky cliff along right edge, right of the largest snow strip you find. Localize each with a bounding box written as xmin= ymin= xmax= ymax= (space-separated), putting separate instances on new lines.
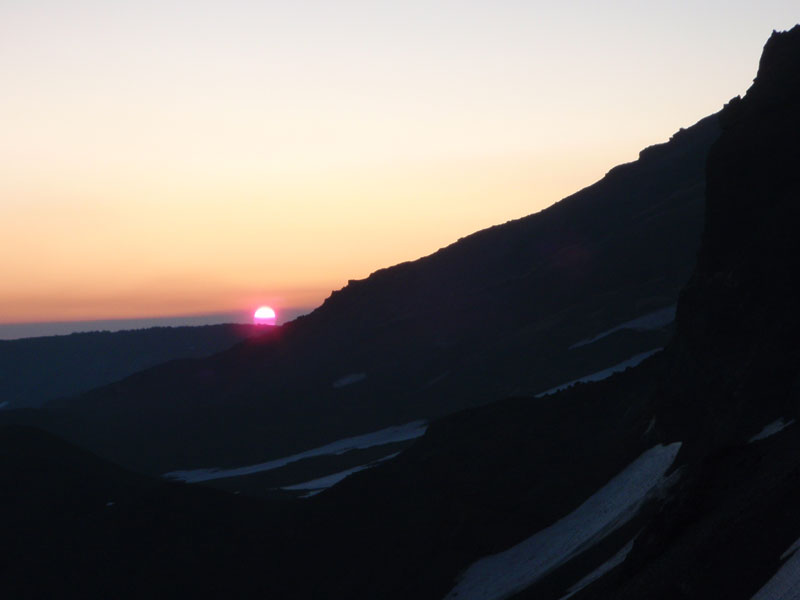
xmin=577 ymin=26 xmax=800 ymax=600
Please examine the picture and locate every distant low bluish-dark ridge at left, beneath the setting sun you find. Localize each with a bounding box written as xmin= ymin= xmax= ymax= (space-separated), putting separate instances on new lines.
xmin=0 ymin=325 xmax=264 ymax=408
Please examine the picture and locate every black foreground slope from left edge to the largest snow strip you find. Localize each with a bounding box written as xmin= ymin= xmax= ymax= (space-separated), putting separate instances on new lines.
xmin=0 ymin=365 xmax=654 ymax=599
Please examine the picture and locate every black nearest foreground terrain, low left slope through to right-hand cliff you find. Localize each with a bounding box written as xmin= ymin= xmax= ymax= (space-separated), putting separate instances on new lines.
xmin=0 ymin=26 xmax=800 ymax=600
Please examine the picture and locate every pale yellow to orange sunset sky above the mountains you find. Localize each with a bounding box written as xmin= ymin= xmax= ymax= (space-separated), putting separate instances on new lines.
xmin=0 ymin=0 xmax=800 ymax=332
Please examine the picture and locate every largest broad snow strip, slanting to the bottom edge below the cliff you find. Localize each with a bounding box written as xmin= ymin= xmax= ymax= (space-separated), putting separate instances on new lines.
xmin=445 ymin=442 xmax=681 ymax=600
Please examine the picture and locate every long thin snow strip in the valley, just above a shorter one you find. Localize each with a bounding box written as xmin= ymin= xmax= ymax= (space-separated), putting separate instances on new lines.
xmin=163 ymin=420 xmax=428 ymax=483
